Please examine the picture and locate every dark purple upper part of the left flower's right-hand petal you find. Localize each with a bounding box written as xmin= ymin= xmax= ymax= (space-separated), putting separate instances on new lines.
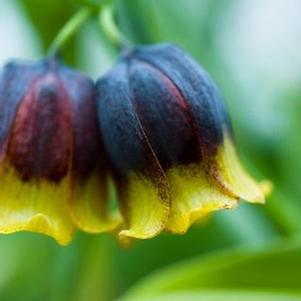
xmin=60 ymin=66 xmax=102 ymax=180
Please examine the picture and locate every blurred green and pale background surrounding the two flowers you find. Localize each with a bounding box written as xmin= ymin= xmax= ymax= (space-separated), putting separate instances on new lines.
xmin=0 ymin=0 xmax=301 ymax=301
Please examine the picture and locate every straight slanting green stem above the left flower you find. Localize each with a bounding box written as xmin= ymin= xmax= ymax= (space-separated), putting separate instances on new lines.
xmin=48 ymin=7 xmax=94 ymax=55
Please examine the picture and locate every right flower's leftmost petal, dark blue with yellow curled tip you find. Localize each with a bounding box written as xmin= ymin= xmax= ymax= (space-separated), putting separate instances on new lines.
xmin=97 ymin=60 xmax=170 ymax=238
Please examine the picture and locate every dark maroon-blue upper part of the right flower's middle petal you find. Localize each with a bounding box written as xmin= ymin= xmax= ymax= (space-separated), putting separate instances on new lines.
xmin=130 ymin=59 xmax=201 ymax=169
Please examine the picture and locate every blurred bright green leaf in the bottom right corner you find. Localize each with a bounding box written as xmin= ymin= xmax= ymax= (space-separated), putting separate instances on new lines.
xmin=120 ymin=241 xmax=301 ymax=300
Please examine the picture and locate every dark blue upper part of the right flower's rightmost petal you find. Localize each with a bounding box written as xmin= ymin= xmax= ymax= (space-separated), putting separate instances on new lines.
xmin=130 ymin=44 xmax=231 ymax=161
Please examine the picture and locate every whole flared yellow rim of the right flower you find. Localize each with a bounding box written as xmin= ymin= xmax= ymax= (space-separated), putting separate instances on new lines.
xmin=115 ymin=131 xmax=271 ymax=239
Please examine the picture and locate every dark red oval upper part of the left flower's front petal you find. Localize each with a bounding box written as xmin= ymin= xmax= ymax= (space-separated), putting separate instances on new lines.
xmin=8 ymin=73 xmax=72 ymax=182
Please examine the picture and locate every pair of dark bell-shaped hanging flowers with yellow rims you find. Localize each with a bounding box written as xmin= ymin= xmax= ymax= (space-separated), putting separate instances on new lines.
xmin=0 ymin=4 xmax=266 ymax=245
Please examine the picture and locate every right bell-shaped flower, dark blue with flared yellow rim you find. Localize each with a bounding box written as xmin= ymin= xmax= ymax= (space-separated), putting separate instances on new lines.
xmin=97 ymin=44 xmax=265 ymax=239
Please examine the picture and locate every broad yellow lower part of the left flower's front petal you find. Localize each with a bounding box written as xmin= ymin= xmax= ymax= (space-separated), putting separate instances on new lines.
xmin=0 ymin=162 xmax=75 ymax=245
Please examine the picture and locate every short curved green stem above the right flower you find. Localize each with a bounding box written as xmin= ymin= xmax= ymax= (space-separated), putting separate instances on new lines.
xmin=99 ymin=4 xmax=131 ymax=49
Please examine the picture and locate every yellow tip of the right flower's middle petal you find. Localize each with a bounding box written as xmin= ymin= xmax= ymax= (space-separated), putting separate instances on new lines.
xmin=166 ymin=164 xmax=238 ymax=234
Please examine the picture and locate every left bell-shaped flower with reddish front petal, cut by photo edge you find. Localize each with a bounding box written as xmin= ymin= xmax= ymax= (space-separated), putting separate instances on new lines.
xmin=0 ymin=57 xmax=119 ymax=245
